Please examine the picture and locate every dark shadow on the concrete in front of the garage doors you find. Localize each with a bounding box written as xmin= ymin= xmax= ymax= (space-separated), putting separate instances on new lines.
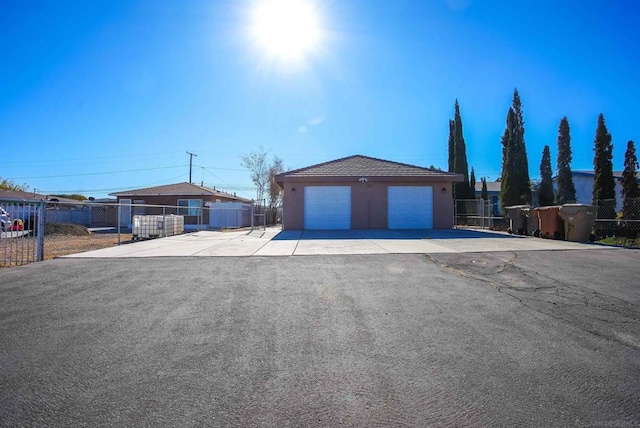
xmin=273 ymin=229 xmax=522 ymax=241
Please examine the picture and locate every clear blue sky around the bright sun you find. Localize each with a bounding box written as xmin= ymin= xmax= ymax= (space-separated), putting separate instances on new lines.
xmin=0 ymin=0 xmax=640 ymax=197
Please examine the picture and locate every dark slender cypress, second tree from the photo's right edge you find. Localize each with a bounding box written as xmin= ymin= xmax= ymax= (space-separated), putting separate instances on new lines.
xmin=593 ymin=113 xmax=616 ymax=207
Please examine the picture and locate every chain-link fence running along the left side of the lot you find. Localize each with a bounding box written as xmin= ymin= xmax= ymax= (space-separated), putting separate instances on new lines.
xmin=0 ymin=199 xmax=266 ymax=267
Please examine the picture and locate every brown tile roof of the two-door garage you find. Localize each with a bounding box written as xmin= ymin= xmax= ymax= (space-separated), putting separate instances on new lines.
xmin=278 ymin=155 xmax=459 ymax=181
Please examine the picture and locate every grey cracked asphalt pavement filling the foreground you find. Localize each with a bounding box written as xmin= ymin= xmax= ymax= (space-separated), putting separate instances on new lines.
xmin=0 ymin=249 xmax=640 ymax=427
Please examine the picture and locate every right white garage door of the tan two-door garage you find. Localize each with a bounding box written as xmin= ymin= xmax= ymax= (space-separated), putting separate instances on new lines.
xmin=387 ymin=186 xmax=433 ymax=229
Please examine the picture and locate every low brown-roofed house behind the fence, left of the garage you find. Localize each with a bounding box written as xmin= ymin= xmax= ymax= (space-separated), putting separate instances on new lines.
xmin=109 ymin=182 xmax=252 ymax=229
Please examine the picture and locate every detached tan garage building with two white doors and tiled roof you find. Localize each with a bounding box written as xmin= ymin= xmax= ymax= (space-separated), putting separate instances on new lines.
xmin=276 ymin=155 xmax=463 ymax=230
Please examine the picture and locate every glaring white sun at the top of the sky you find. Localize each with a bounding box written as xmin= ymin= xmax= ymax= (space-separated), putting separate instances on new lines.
xmin=252 ymin=0 xmax=321 ymax=61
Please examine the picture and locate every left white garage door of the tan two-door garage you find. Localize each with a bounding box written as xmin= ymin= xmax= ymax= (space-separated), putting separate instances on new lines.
xmin=304 ymin=186 xmax=351 ymax=230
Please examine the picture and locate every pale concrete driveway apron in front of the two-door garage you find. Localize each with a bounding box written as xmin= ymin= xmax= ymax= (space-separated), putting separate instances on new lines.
xmin=67 ymin=228 xmax=613 ymax=258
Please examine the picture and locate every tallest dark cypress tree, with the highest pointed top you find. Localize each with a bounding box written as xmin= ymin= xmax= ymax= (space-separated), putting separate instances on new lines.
xmin=500 ymin=89 xmax=531 ymax=207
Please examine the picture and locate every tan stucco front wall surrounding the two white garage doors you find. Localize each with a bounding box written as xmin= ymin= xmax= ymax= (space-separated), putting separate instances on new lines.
xmin=282 ymin=178 xmax=453 ymax=230
